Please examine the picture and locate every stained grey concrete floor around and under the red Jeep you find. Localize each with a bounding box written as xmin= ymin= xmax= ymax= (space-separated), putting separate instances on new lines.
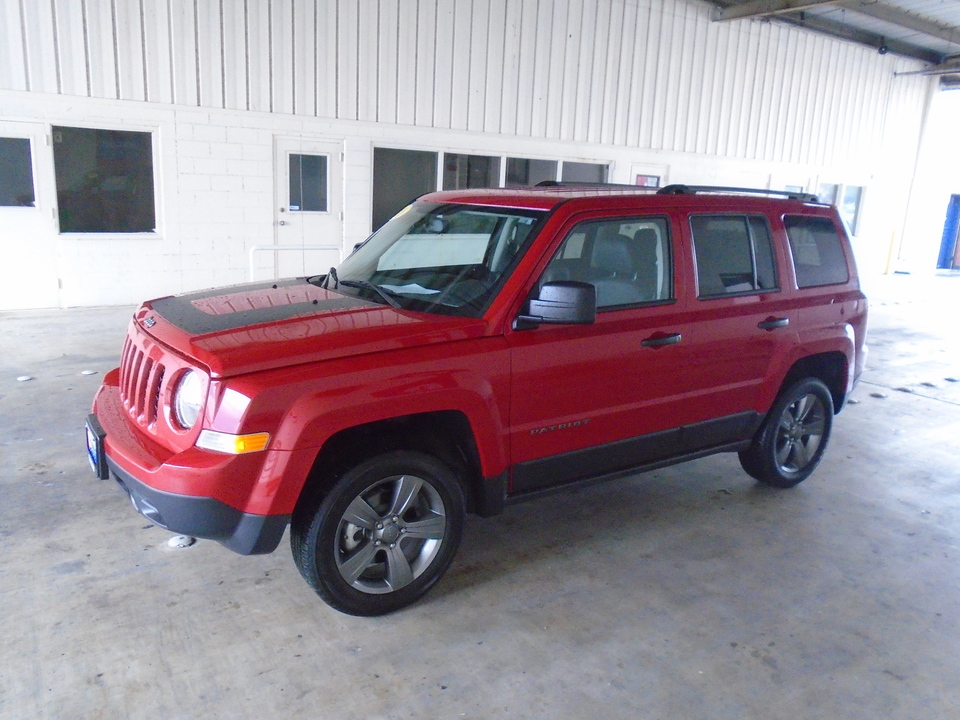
xmin=0 ymin=276 xmax=960 ymax=720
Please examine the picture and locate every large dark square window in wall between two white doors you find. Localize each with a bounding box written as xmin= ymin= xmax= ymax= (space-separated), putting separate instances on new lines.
xmin=53 ymin=127 xmax=156 ymax=233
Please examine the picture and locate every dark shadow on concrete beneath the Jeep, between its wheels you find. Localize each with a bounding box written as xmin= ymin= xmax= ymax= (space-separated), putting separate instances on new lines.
xmin=426 ymin=456 xmax=804 ymax=602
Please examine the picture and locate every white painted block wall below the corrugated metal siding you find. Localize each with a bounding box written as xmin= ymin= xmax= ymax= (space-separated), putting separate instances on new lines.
xmin=0 ymin=90 xmax=928 ymax=309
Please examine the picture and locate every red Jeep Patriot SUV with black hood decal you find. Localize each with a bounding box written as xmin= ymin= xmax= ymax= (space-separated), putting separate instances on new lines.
xmin=87 ymin=184 xmax=867 ymax=615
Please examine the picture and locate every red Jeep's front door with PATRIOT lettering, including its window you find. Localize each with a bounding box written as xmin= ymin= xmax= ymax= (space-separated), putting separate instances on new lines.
xmin=507 ymin=214 xmax=689 ymax=492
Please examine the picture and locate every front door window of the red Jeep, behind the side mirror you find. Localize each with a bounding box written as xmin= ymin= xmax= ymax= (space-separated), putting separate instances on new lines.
xmin=540 ymin=217 xmax=673 ymax=310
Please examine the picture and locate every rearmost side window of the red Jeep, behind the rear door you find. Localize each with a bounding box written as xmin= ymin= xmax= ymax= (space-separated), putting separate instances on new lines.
xmin=783 ymin=215 xmax=850 ymax=288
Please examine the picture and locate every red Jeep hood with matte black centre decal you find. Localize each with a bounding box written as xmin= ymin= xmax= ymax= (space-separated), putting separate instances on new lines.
xmin=133 ymin=278 xmax=486 ymax=377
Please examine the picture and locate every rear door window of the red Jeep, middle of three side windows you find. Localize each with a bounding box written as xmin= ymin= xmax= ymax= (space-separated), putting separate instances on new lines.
xmin=690 ymin=215 xmax=778 ymax=298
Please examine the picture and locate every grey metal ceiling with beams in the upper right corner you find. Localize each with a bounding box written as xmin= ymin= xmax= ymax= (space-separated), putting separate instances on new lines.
xmin=713 ymin=0 xmax=960 ymax=87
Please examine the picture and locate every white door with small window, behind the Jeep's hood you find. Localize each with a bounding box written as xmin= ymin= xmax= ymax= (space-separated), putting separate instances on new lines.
xmin=266 ymin=138 xmax=343 ymax=279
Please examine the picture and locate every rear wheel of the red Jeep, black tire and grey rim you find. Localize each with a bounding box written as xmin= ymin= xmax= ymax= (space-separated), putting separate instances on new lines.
xmin=740 ymin=378 xmax=833 ymax=488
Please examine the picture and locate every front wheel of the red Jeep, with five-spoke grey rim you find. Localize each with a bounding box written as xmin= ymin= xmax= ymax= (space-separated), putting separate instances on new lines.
xmin=290 ymin=451 xmax=465 ymax=616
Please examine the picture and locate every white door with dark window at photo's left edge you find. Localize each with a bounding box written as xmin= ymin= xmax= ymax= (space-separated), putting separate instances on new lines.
xmin=0 ymin=121 xmax=60 ymax=310
